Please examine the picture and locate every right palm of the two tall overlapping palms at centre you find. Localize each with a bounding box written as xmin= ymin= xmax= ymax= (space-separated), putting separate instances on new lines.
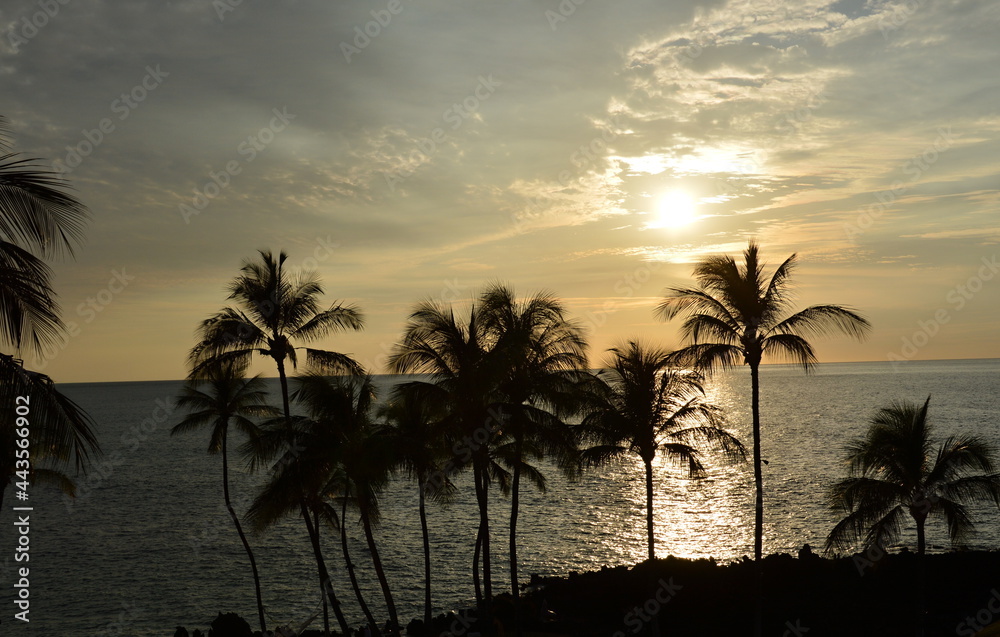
xmin=481 ymin=284 xmax=587 ymax=620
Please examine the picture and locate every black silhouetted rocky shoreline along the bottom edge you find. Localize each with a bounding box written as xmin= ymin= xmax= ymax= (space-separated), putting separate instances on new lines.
xmin=176 ymin=551 xmax=1000 ymax=637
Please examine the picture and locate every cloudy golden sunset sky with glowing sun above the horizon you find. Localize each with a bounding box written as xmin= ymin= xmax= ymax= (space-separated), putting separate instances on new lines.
xmin=0 ymin=0 xmax=1000 ymax=382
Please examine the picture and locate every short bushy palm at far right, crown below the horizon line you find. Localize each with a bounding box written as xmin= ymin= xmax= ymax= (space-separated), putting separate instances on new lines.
xmin=826 ymin=396 xmax=1000 ymax=555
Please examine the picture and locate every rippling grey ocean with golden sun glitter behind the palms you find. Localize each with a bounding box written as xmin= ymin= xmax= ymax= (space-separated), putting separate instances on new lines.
xmin=0 ymin=359 xmax=1000 ymax=637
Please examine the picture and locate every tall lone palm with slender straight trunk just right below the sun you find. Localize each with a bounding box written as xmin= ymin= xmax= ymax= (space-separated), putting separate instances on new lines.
xmin=656 ymin=240 xmax=871 ymax=562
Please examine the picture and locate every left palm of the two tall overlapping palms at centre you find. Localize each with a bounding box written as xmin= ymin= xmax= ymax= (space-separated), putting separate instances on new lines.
xmin=389 ymin=302 xmax=506 ymax=620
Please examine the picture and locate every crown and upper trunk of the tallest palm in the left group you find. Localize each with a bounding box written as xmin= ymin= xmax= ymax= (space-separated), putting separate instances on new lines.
xmin=189 ymin=250 xmax=364 ymax=418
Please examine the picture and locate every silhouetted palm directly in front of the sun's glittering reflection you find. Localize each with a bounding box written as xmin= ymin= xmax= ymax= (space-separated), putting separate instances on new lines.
xmin=580 ymin=341 xmax=746 ymax=560
